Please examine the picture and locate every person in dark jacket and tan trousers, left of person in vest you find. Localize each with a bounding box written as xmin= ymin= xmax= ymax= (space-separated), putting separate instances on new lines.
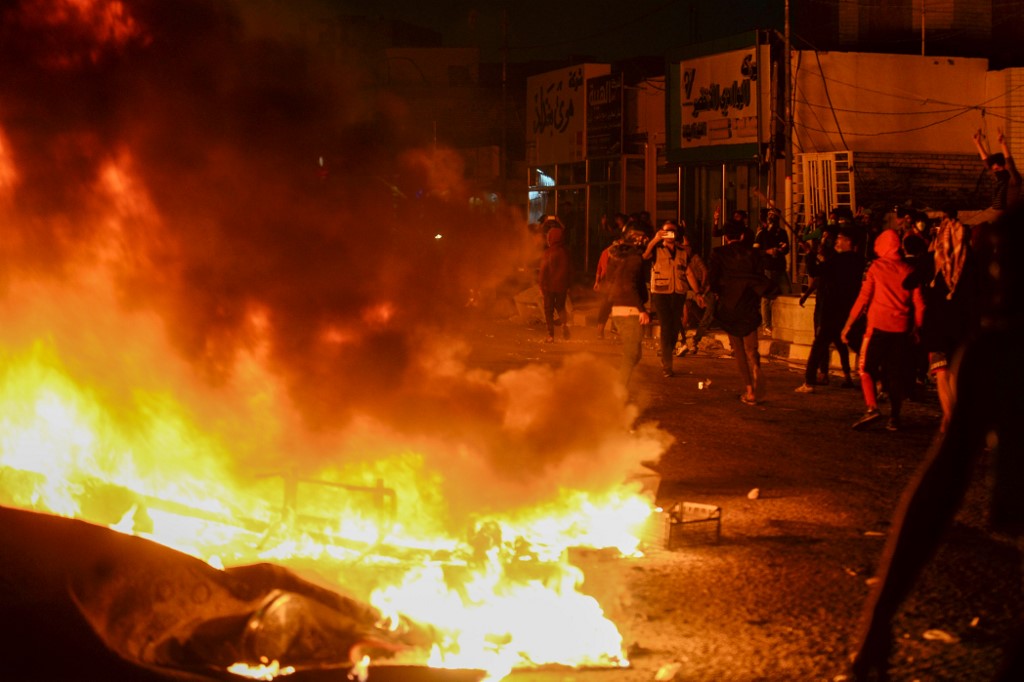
xmin=604 ymin=226 xmax=650 ymax=386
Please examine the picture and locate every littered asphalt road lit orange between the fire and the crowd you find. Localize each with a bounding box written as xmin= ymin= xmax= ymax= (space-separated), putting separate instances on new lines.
xmin=472 ymin=319 xmax=1024 ymax=682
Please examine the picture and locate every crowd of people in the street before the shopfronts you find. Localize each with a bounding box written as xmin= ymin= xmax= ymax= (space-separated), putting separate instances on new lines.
xmin=524 ymin=132 xmax=1021 ymax=430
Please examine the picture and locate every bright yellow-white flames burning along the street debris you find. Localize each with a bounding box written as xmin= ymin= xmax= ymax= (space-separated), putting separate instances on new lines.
xmin=0 ymin=280 xmax=651 ymax=679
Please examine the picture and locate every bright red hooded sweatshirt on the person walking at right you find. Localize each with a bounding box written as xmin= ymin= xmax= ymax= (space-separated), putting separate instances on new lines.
xmin=847 ymin=229 xmax=925 ymax=334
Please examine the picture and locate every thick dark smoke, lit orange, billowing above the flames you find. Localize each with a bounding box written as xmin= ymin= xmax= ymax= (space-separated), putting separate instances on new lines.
xmin=0 ymin=0 xmax=667 ymax=516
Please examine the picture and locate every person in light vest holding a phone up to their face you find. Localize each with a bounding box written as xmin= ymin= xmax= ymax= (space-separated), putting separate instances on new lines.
xmin=643 ymin=220 xmax=690 ymax=378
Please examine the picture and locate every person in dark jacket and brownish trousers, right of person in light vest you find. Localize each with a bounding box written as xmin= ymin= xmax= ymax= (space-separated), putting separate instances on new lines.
xmin=708 ymin=224 xmax=771 ymax=404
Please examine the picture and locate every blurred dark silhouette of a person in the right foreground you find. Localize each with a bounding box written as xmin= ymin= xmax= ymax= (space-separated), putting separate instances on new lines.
xmin=849 ymin=203 xmax=1024 ymax=682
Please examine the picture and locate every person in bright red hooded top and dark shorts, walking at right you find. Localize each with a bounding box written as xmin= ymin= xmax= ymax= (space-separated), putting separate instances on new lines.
xmin=842 ymin=229 xmax=925 ymax=431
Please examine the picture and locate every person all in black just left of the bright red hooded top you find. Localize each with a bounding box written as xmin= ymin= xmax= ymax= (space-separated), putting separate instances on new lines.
xmin=797 ymin=228 xmax=864 ymax=393
